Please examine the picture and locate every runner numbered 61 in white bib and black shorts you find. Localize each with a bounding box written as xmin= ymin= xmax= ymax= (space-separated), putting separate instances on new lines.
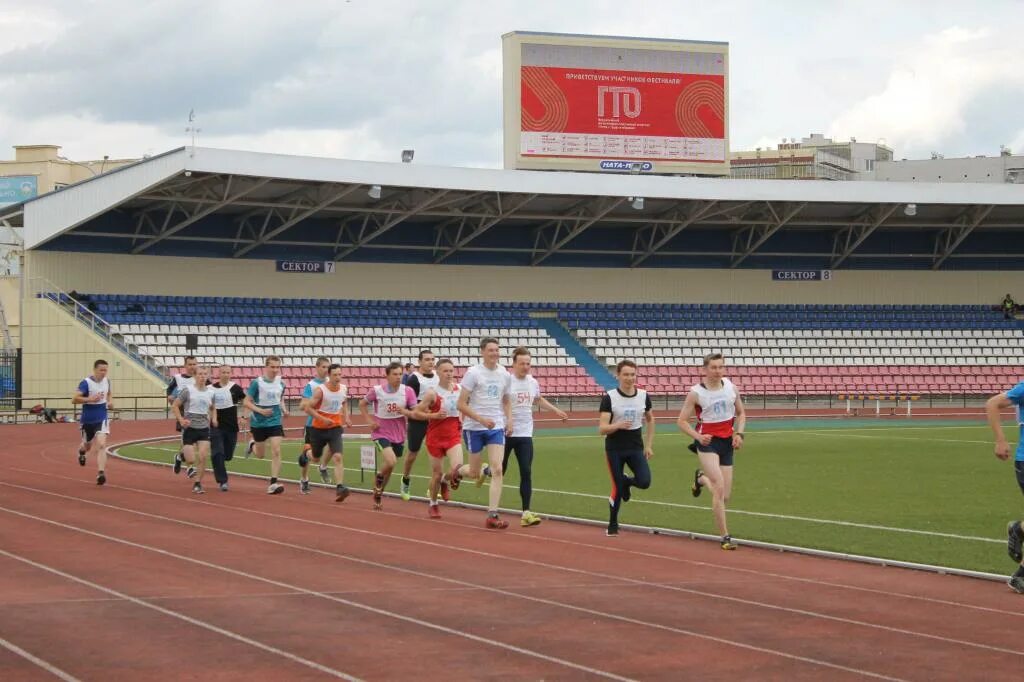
xmin=677 ymin=353 xmax=746 ymax=550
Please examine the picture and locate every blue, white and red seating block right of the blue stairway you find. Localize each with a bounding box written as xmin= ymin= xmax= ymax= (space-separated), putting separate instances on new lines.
xmin=566 ymin=304 xmax=1024 ymax=395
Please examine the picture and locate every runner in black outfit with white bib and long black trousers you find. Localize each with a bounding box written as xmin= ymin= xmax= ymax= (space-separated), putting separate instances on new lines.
xmin=597 ymin=359 xmax=654 ymax=537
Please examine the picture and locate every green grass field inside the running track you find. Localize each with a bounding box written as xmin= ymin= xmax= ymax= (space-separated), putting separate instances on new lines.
xmin=114 ymin=420 xmax=1024 ymax=573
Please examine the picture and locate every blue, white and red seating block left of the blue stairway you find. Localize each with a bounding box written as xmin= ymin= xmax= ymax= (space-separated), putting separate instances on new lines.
xmin=90 ymin=295 xmax=600 ymax=396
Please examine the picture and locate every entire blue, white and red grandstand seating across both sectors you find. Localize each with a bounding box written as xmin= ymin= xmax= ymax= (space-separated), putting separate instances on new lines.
xmin=74 ymin=294 xmax=1024 ymax=395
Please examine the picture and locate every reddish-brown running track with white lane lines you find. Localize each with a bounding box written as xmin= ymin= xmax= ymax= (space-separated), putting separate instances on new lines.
xmin=0 ymin=422 xmax=1024 ymax=682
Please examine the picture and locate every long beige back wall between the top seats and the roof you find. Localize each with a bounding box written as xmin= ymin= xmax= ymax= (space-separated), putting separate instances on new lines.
xmin=26 ymin=251 xmax=1024 ymax=305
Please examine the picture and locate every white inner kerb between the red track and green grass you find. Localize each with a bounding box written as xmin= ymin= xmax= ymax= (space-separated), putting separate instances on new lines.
xmin=106 ymin=436 xmax=1007 ymax=583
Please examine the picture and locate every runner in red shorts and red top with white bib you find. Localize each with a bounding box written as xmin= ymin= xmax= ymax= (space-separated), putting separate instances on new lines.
xmin=414 ymin=358 xmax=462 ymax=518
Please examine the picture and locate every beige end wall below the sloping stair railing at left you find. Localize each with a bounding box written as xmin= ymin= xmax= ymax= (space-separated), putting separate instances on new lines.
xmin=22 ymin=299 xmax=166 ymax=403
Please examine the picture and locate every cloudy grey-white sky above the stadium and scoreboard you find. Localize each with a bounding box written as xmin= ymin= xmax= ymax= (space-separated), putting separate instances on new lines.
xmin=0 ymin=0 xmax=1024 ymax=167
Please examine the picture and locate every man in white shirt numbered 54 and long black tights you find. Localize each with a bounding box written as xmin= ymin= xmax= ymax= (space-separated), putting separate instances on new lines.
xmin=502 ymin=346 xmax=568 ymax=527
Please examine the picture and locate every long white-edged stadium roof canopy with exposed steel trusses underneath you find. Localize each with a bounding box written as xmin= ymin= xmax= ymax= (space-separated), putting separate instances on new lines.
xmin=0 ymin=147 xmax=1024 ymax=269
